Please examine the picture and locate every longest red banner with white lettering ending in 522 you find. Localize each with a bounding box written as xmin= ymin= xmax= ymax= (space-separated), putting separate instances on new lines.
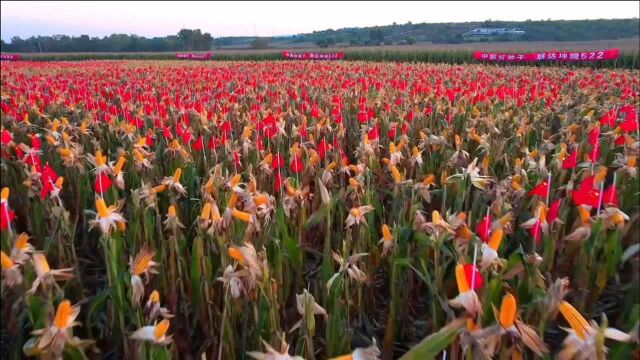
xmin=473 ymin=49 xmax=620 ymax=62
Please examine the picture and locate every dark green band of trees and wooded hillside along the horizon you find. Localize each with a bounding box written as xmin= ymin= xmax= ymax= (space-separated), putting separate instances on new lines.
xmin=1 ymin=18 xmax=640 ymax=53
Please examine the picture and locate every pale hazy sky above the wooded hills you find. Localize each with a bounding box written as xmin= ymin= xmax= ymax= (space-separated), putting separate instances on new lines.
xmin=0 ymin=1 xmax=640 ymax=41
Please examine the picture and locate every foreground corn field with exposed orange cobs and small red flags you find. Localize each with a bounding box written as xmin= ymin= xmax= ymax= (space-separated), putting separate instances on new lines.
xmin=0 ymin=60 xmax=640 ymax=360
